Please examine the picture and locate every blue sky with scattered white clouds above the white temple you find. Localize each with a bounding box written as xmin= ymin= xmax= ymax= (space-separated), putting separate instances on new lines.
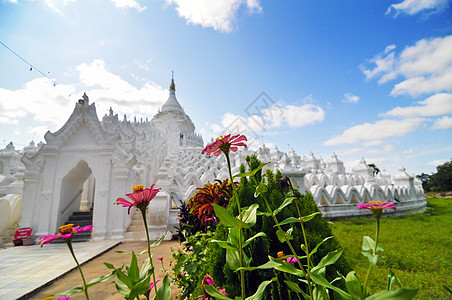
xmin=0 ymin=0 xmax=452 ymax=175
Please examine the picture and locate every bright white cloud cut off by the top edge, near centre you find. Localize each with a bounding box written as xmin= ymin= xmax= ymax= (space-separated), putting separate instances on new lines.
xmin=166 ymin=0 xmax=262 ymax=32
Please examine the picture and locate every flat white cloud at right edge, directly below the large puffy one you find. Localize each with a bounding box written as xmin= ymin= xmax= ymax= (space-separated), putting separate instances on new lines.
xmin=385 ymin=93 xmax=452 ymax=117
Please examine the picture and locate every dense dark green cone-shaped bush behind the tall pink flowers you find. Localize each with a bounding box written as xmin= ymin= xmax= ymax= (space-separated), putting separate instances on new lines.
xmin=195 ymin=156 xmax=350 ymax=299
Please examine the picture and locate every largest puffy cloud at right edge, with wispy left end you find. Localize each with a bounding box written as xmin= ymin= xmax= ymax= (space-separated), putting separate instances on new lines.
xmin=361 ymin=35 xmax=452 ymax=96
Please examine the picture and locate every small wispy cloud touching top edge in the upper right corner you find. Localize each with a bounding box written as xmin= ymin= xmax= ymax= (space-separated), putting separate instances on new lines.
xmin=386 ymin=0 xmax=450 ymax=18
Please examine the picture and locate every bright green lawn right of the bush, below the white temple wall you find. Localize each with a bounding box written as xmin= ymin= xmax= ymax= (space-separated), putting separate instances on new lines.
xmin=333 ymin=198 xmax=452 ymax=299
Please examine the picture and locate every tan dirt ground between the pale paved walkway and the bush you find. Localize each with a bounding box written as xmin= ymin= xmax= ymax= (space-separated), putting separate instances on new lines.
xmin=28 ymin=241 xmax=180 ymax=300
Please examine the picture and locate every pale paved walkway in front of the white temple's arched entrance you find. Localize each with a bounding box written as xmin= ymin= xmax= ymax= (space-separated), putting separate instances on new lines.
xmin=0 ymin=241 xmax=120 ymax=300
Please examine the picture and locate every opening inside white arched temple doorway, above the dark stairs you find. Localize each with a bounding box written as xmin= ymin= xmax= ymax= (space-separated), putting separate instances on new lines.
xmin=57 ymin=160 xmax=95 ymax=227
